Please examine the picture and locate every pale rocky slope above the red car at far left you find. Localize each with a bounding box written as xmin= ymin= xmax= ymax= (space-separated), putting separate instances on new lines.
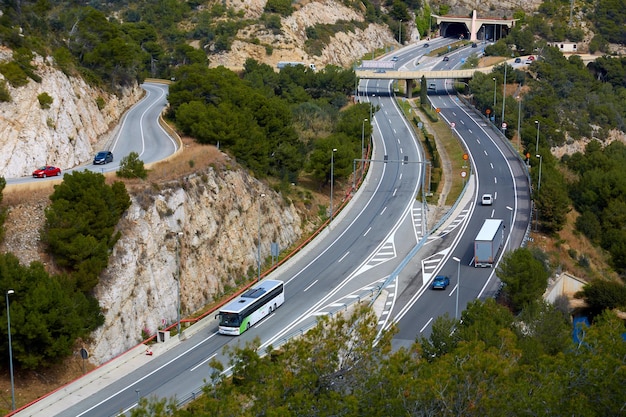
xmin=0 ymin=49 xmax=142 ymax=178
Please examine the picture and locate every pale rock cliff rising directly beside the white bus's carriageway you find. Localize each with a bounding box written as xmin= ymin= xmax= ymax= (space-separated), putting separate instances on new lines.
xmin=90 ymin=165 xmax=302 ymax=363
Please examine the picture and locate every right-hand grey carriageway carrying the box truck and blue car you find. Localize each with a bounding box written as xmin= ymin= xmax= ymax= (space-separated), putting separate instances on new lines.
xmin=389 ymin=40 xmax=531 ymax=348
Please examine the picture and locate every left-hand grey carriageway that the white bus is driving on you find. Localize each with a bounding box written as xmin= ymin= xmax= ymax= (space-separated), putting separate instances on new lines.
xmin=44 ymin=48 xmax=432 ymax=417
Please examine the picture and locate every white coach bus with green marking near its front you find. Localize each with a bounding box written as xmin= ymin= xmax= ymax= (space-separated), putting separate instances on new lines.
xmin=215 ymin=279 xmax=285 ymax=336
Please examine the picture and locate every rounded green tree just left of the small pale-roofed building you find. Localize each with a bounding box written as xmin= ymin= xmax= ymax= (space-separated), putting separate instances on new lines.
xmin=496 ymin=248 xmax=549 ymax=311
